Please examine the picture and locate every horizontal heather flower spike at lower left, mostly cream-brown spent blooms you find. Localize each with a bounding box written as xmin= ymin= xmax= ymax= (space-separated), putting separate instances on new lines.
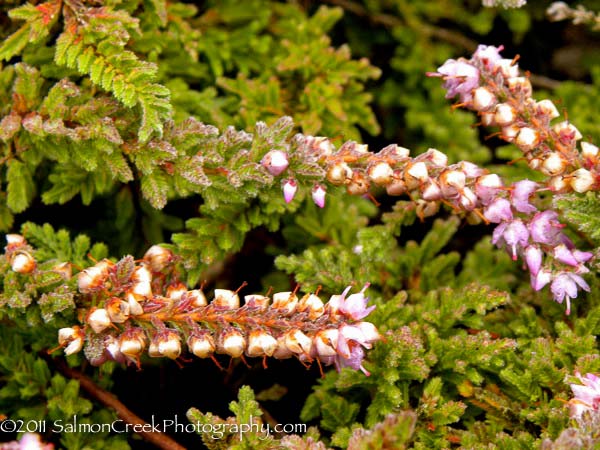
xmin=6 ymin=235 xmax=380 ymax=375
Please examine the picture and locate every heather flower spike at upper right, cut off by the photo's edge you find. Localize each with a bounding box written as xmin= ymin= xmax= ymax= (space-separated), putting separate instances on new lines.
xmin=428 ymin=45 xmax=600 ymax=193
